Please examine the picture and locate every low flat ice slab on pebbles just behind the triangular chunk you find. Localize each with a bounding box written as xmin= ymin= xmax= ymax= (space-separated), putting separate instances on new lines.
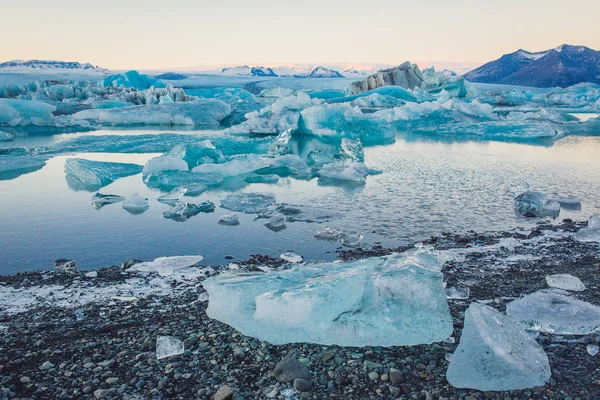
xmin=506 ymin=290 xmax=600 ymax=335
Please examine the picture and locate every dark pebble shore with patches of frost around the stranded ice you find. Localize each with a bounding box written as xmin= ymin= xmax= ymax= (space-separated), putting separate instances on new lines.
xmin=0 ymin=220 xmax=600 ymax=400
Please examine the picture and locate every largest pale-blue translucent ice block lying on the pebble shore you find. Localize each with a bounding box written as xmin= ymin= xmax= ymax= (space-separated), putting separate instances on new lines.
xmin=203 ymin=250 xmax=452 ymax=346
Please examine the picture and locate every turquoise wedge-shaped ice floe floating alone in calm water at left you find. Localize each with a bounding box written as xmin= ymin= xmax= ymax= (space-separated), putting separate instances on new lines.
xmin=65 ymin=158 xmax=142 ymax=192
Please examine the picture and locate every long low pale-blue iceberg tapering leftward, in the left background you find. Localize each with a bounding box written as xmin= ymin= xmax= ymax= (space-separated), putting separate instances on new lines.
xmin=73 ymin=99 xmax=231 ymax=128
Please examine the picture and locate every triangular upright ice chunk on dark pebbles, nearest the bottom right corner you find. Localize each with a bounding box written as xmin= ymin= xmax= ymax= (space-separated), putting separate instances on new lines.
xmin=446 ymin=303 xmax=550 ymax=391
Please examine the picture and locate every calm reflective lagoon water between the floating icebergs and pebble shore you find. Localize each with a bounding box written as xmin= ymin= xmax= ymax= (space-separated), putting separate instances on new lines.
xmin=0 ymin=131 xmax=600 ymax=274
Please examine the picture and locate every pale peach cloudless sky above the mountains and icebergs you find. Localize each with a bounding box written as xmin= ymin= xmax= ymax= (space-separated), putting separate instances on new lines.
xmin=0 ymin=0 xmax=600 ymax=69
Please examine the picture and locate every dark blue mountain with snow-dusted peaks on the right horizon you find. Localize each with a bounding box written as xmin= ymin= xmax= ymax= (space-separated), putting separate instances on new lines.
xmin=464 ymin=44 xmax=600 ymax=87
